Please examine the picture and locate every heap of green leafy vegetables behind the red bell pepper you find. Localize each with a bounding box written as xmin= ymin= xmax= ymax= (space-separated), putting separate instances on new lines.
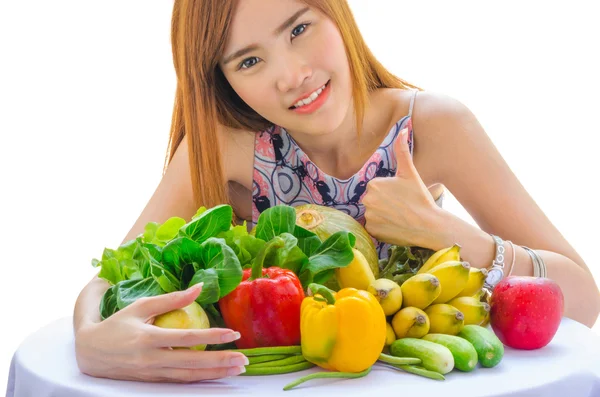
xmin=92 ymin=205 xmax=356 ymax=326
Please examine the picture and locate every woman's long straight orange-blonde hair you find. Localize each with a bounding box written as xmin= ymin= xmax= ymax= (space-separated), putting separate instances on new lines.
xmin=164 ymin=0 xmax=419 ymax=208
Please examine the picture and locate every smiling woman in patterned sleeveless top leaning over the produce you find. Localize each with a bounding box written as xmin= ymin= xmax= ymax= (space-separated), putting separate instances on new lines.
xmin=74 ymin=0 xmax=600 ymax=382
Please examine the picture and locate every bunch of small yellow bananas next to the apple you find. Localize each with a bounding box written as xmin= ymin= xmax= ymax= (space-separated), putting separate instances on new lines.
xmin=367 ymin=244 xmax=490 ymax=345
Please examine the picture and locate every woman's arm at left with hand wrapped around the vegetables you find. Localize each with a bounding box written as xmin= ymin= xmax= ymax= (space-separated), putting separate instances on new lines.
xmin=73 ymin=132 xmax=248 ymax=383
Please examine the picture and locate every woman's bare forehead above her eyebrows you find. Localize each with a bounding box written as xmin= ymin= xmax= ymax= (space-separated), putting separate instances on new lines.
xmin=227 ymin=0 xmax=310 ymax=46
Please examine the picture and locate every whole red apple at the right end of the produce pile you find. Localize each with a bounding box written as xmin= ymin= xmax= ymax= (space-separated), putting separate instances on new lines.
xmin=490 ymin=276 xmax=564 ymax=350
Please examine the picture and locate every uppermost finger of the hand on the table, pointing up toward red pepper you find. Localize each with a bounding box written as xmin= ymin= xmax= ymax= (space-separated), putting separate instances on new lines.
xmin=125 ymin=283 xmax=203 ymax=322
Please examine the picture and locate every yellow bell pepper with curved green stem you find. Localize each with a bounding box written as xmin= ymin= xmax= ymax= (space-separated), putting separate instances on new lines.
xmin=300 ymin=283 xmax=386 ymax=372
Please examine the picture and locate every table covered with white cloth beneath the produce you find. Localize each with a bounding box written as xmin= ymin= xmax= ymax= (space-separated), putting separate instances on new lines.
xmin=7 ymin=317 xmax=600 ymax=397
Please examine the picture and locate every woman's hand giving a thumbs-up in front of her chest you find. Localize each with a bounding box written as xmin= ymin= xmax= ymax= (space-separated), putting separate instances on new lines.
xmin=362 ymin=129 xmax=442 ymax=249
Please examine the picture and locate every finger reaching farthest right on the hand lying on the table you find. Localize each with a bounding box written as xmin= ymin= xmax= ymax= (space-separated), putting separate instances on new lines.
xmin=149 ymin=349 xmax=249 ymax=369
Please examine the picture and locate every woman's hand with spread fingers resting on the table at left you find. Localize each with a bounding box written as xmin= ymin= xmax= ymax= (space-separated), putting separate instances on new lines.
xmin=75 ymin=285 xmax=248 ymax=383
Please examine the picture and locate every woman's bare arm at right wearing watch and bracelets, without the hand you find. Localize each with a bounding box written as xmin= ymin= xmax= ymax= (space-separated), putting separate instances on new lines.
xmin=415 ymin=93 xmax=600 ymax=327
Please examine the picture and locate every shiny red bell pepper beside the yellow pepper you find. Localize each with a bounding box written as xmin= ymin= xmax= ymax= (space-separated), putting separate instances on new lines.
xmin=219 ymin=261 xmax=304 ymax=349
